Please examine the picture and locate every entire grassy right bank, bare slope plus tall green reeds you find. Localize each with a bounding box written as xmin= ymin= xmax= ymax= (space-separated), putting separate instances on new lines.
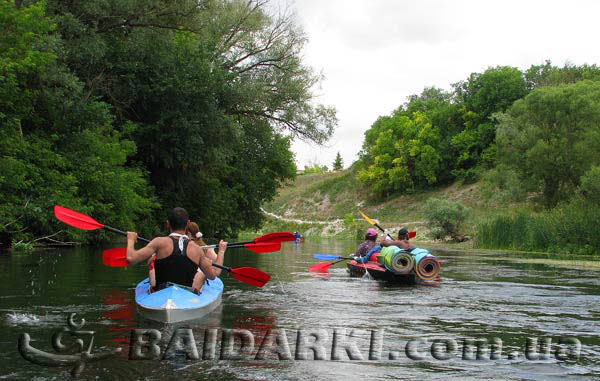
xmin=253 ymin=169 xmax=600 ymax=255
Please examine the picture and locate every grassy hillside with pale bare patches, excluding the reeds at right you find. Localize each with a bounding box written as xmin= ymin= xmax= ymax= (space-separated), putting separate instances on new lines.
xmin=255 ymin=169 xmax=497 ymax=240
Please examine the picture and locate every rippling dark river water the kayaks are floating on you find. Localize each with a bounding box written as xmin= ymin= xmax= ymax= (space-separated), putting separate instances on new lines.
xmin=0 ymin=241 xmax=600 ymax=380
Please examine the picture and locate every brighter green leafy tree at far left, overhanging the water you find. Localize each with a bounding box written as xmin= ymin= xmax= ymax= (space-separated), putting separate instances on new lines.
xmin=0 ymin=1 xmax=154 ymax=245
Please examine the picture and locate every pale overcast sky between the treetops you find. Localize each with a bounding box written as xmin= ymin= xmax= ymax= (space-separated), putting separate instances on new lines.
xmin=276 ymin=0 xmax=600 ymax=169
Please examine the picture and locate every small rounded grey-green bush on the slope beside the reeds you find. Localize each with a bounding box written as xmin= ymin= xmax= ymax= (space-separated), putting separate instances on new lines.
xmin=423 ymin=198 xmax=469 ymax=239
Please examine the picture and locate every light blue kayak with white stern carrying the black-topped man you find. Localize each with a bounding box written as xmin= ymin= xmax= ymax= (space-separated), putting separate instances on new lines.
xmin=135 ymin=277 xmax=223 ymax=323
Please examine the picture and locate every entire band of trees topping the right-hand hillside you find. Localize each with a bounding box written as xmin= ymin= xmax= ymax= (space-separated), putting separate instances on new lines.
xmin=357 ymin=62 xmax=600 ymax=199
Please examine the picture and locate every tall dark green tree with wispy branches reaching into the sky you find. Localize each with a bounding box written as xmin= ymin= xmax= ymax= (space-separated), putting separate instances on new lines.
xmin=49 ymin=0 xmax=336 ymax=236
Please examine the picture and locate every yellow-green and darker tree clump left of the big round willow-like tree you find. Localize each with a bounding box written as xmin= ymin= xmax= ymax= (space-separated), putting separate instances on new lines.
xmin=359 ymin=67 xmax=528 ymax=196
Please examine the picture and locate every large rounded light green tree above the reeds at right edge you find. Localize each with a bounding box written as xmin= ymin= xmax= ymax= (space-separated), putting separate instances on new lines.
xmin=497 ymin=81 xmax=600 ymax=207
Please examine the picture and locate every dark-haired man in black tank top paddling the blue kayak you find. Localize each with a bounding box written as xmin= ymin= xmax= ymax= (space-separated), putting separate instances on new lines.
xmin=127 ymin=208 xmax=227 ymax=292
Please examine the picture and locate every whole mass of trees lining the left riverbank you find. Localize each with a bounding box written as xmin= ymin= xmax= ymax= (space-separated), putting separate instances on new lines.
xmin=0 ymin=0 xmax=337 ymax=244
